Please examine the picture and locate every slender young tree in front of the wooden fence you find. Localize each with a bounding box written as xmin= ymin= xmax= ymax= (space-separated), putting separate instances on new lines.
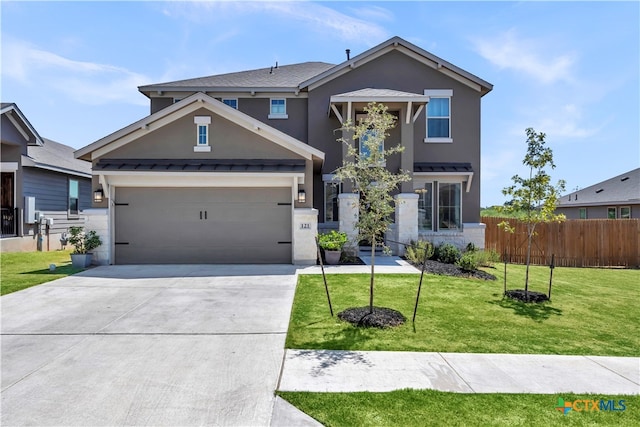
xmin=499 ymin=128 xmax=565 ymax=300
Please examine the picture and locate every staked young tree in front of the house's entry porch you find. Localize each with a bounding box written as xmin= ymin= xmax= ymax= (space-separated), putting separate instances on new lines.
xmin=336 ymin=102 xmax=410 ymax=313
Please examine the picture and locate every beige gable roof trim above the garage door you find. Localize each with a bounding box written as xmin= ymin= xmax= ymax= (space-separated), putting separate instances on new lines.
xmin=75 ymin=92 xmax=324 ymax=160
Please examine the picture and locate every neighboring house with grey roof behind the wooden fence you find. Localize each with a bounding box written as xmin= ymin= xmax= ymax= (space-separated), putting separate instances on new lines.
xmin=556 ymin=168 xmax=640 ymax=219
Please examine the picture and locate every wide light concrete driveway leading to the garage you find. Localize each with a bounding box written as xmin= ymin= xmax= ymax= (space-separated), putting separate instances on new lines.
xmin=0 ymin=265 xmax=296 ymax=426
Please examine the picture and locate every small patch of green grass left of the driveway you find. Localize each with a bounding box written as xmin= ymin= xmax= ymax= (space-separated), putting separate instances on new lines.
xmin=0 ymin=251 xmax=82 ymax=295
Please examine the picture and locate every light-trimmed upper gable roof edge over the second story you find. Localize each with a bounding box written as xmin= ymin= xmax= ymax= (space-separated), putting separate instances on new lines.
xmin=300 ymin=37 xmax=493 ymax=95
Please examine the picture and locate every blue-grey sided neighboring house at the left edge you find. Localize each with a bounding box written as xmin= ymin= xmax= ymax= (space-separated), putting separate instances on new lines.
xmin=0 ymin=103 xmax=91 ymax=252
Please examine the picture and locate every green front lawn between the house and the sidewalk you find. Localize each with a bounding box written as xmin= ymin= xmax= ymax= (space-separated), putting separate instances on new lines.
xmin=286 ymin=265 xmax=640 ymax=356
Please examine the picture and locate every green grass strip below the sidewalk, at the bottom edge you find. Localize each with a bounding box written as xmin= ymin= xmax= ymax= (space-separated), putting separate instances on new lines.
xmin=278 ymin=390 xmax=640 ymax=427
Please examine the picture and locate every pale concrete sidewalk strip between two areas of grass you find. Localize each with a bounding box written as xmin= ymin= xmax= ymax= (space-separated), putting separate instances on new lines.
xmin=279 ymin=350 xmax=640 ymax=394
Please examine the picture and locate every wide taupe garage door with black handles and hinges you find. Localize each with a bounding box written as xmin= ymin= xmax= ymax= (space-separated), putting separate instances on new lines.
xmin=115 ymin=188 xmax=291 ymax=264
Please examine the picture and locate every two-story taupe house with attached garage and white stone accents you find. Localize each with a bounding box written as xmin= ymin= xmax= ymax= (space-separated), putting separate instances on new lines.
xmin=76 ymin=37 xmax=492 ymax=264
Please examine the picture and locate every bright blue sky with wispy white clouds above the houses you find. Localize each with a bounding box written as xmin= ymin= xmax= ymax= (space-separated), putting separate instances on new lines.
xmin=0 ymin=1 xmax=640 ymax=206
